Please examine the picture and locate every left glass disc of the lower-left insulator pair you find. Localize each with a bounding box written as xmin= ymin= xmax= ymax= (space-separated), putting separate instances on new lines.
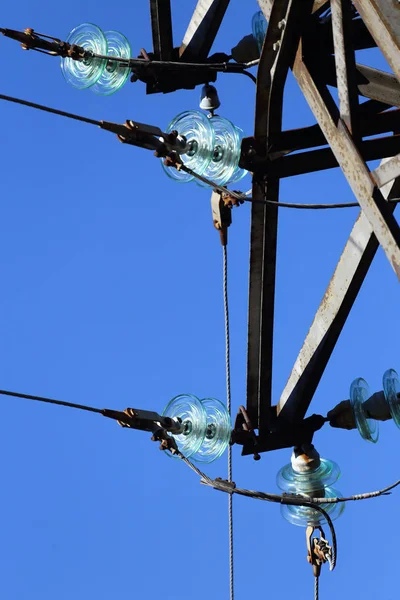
xmin=163 ymin=394 xmax=207 ymax=458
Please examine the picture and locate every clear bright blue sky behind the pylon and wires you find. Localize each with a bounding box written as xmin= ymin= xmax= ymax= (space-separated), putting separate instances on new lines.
xmin=0 ymin=0 xmax=400 ymax=600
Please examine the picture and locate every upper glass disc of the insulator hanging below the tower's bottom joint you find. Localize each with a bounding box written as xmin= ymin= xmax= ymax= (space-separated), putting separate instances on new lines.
xmin=276 ymin=458 xmax=340 ymax=494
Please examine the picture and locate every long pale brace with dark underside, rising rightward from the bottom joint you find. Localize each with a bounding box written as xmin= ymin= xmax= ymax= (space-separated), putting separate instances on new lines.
xmin=277 ymin=169 xmax=400 ymax=422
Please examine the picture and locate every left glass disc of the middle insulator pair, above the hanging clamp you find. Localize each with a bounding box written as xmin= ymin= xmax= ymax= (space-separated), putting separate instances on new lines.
xmin=161 ymin=110 xmax=214 ymax=183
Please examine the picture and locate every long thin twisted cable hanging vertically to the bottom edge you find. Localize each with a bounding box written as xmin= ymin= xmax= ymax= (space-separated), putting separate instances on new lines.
xmin=222 ymin=245 xmax=235 ymax=600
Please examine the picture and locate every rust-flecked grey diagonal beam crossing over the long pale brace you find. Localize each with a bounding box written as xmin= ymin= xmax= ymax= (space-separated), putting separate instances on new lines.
xmin=293 ymin=48 xmax=400 ymax=279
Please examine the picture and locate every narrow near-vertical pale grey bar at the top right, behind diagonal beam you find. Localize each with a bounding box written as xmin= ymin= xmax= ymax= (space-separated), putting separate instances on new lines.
xmin=331 ymin=0 xmax=359 ymax=137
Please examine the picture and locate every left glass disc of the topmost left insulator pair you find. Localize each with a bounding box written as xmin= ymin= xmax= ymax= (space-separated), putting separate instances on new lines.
xmin=61 ymin=23 xmax=107 ymax=90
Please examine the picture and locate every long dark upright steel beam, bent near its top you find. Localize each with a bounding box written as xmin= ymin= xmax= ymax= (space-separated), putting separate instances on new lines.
xmin=246 ymin=0 xmax=313 ymax=437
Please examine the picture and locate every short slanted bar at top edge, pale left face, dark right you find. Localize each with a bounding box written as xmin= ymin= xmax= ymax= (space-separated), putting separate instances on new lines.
xmin=179 ymin=0 xmax=229 ymax=60
